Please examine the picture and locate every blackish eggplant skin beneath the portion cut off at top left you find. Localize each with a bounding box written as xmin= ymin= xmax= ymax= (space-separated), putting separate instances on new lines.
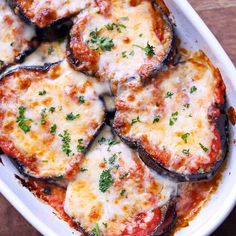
xmin=7 ymin=0 xmax=76 ymax=41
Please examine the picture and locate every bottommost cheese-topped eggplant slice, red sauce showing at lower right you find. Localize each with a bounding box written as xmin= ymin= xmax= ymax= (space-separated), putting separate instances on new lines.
xmin=64 ymin=126 xmax=177 ymax=236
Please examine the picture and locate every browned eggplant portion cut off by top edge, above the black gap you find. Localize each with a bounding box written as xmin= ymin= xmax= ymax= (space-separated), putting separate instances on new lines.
xmin=7 ymin=0 xmax=93 ymax=29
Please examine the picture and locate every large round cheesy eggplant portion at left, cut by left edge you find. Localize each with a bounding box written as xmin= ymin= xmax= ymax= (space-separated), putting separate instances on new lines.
xmin=0 ymin=61 xmax=105 ymax=179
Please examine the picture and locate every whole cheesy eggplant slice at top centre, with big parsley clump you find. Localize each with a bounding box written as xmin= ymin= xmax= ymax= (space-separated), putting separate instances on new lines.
xmin=67 ymin=0 xmax=175 ymax=91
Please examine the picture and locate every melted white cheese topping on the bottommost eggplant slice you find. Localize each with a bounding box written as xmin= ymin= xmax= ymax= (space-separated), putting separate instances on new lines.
xmin=64 ymin=128 xmax=176 ymax=236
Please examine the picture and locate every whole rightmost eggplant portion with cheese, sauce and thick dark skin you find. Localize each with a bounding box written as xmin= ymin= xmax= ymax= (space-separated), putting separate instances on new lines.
xmin=113 ymin=51 xmax=227 ymax=181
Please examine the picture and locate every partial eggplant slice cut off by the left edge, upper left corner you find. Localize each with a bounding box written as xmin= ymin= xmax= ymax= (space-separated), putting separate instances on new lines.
xmin=0 ymin=1 xmax=38 ymax=72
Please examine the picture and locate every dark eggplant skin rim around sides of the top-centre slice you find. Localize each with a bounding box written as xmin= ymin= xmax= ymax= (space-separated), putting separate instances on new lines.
xmin=66 ymin=1 xmax=177 ymax=82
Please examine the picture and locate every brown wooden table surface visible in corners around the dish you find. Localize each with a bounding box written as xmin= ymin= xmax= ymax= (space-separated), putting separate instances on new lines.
xmin=0 ymin=0 xmax=236 ymax=236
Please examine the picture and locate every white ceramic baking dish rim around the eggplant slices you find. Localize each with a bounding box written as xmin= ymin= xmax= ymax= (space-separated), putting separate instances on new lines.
xmin=0 ymin=0 xmax=236 ymax=236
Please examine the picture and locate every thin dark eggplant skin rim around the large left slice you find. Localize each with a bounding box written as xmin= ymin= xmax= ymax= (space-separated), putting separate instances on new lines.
xmin=0 ymin=61 xmax=108 ymax=183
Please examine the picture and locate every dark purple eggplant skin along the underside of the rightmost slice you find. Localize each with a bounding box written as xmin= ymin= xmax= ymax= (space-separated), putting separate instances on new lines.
xmin=114 ymin=102 xmax=229 ymax=182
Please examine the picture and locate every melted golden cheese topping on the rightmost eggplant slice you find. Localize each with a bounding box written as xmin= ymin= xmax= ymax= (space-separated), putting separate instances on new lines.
xmin=115 ymin=51 xmax=221 ymax=174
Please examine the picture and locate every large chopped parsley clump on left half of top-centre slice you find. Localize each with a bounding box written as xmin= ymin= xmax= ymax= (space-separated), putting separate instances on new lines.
xmin=89 ymin=28 xmax=114 ymax=51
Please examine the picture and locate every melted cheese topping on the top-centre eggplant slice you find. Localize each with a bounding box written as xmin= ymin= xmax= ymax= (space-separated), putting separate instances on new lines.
xmin=72 ymin=0 xmax=171 ymax=83
